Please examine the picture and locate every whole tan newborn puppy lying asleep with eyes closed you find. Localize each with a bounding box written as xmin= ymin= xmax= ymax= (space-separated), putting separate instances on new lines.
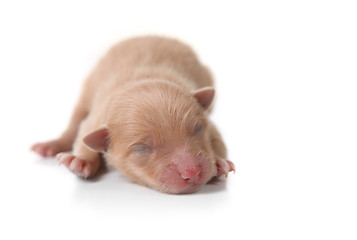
xmin=32 ymin=37 xmax=234 ymax=194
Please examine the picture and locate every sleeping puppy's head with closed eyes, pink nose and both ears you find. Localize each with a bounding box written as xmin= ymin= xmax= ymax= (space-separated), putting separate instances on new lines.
xmin=84 ymin=80 xmax=216 ymax=193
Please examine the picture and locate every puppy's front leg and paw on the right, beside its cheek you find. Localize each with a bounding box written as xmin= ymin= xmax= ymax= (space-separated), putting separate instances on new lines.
xmin=210 ymin=124 xmax=235 ymax=177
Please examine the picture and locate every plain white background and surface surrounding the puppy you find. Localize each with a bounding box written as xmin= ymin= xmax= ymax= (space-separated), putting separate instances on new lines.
xmin=0 ymin=0 xmax=357 ymax=240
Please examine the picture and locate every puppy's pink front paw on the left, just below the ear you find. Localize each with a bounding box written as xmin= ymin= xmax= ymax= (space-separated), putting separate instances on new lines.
xmin=56 ymin=153 xmax=98 ymax=178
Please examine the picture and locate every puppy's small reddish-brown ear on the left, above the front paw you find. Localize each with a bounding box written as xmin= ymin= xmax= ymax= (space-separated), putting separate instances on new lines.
xmin=83 ymin=127 xmax=109 ymax=152
